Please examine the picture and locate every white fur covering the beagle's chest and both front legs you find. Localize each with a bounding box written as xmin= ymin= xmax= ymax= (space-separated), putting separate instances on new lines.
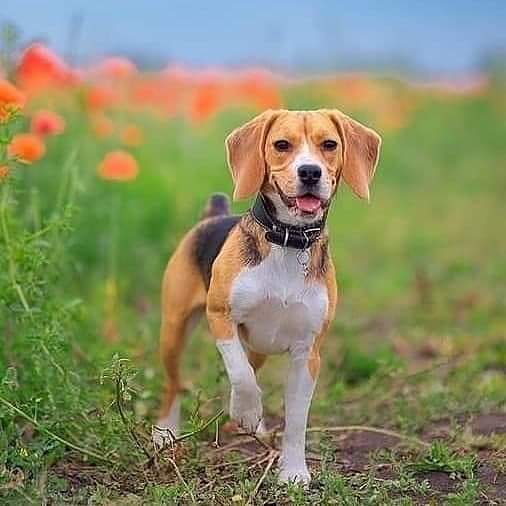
xmin=223 ymin=245 xmax=328 ymax=483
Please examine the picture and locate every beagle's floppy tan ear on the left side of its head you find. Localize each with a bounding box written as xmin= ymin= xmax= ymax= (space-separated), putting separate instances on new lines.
xmin=225 ymin=110 xmax=279 ymax=200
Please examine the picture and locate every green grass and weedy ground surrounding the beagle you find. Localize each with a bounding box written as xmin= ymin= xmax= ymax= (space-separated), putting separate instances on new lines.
xmin=0 ymin=77 xmax=506 ymax=505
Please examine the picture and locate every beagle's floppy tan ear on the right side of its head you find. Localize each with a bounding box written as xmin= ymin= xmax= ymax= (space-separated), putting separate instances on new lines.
xmin=326 ymin=109 xmax=381 ymax=200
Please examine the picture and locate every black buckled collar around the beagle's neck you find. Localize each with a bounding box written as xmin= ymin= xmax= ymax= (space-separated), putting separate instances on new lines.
xmin=249 ymin=194 xmax=327 ymax=250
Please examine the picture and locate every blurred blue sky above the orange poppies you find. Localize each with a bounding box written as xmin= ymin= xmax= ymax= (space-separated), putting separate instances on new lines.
xmin=0 ymin=0 xmax=506 ymax=77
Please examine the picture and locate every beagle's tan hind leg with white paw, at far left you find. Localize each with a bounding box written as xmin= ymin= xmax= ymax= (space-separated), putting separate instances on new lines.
xmin=153 ymin=235 xmax=206 ymax=445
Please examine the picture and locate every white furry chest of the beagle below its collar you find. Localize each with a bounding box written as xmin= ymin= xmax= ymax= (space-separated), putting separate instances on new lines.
xmin=230 ymin=245 xmax=328 ymax=354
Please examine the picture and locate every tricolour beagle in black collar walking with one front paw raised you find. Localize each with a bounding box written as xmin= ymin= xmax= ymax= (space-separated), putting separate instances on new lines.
xmin=153 ymin=110 xmax=381 ymax=484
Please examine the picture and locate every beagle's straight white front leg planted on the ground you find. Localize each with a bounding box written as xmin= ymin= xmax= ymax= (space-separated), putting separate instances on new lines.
xmin=280 ymin=351 xmax=319 ymax=484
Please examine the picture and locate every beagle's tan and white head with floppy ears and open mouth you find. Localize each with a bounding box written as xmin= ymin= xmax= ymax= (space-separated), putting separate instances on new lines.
xmin=226 ymin=110 xmax=381 ymax=225
